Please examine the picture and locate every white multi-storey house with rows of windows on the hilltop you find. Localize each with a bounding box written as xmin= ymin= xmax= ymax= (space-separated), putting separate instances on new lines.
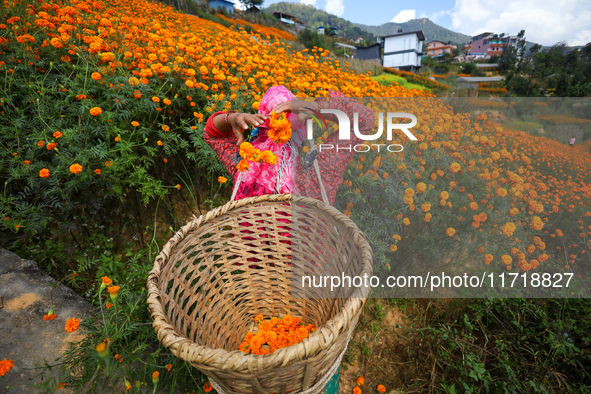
xmin=382 ymin=29 xmax=425 ymax=71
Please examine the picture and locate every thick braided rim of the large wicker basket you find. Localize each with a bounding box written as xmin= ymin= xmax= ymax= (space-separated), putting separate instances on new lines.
xmin=147 ymin=194 xmax=373 ymax=374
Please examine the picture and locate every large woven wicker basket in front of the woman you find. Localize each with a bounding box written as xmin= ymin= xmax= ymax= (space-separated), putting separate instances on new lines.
xmin=148 ymin=194 xmax=372 ymax=394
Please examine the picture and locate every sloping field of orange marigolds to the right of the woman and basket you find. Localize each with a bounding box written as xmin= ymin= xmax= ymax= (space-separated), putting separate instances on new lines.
xmin=337 ymin=98 xmax=591 ymax=290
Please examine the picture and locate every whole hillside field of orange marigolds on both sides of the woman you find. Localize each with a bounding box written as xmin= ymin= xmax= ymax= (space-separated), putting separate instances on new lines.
xmin=0 ymin=0 xmax=591 ymax=392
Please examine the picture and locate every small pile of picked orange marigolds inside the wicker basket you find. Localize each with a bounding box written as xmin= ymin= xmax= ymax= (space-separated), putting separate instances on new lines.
xmin=240 ymin=315 xmax=316 ymax=354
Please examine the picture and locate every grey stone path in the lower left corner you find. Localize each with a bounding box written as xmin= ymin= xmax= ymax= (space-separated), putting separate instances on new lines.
xmin=0 ymin=248 xmax=92 ymax=394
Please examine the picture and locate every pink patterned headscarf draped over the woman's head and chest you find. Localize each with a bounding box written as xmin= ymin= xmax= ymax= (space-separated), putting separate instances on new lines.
xmin=235 ymin=85 xmax=305 ymax=200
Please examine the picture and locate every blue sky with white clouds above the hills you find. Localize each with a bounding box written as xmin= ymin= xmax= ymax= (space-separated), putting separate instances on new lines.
xmin=240 ymin=0 xmax=591 ymax=45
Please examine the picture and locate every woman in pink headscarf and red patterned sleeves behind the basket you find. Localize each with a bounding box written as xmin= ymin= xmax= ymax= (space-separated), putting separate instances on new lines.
xmin=203 ymin=86 xmax=374 ymax=205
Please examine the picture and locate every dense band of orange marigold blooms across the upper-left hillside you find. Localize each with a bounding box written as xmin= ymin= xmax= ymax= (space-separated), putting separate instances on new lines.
xmin=0 ymin=0 xmax=433 ymax=107
